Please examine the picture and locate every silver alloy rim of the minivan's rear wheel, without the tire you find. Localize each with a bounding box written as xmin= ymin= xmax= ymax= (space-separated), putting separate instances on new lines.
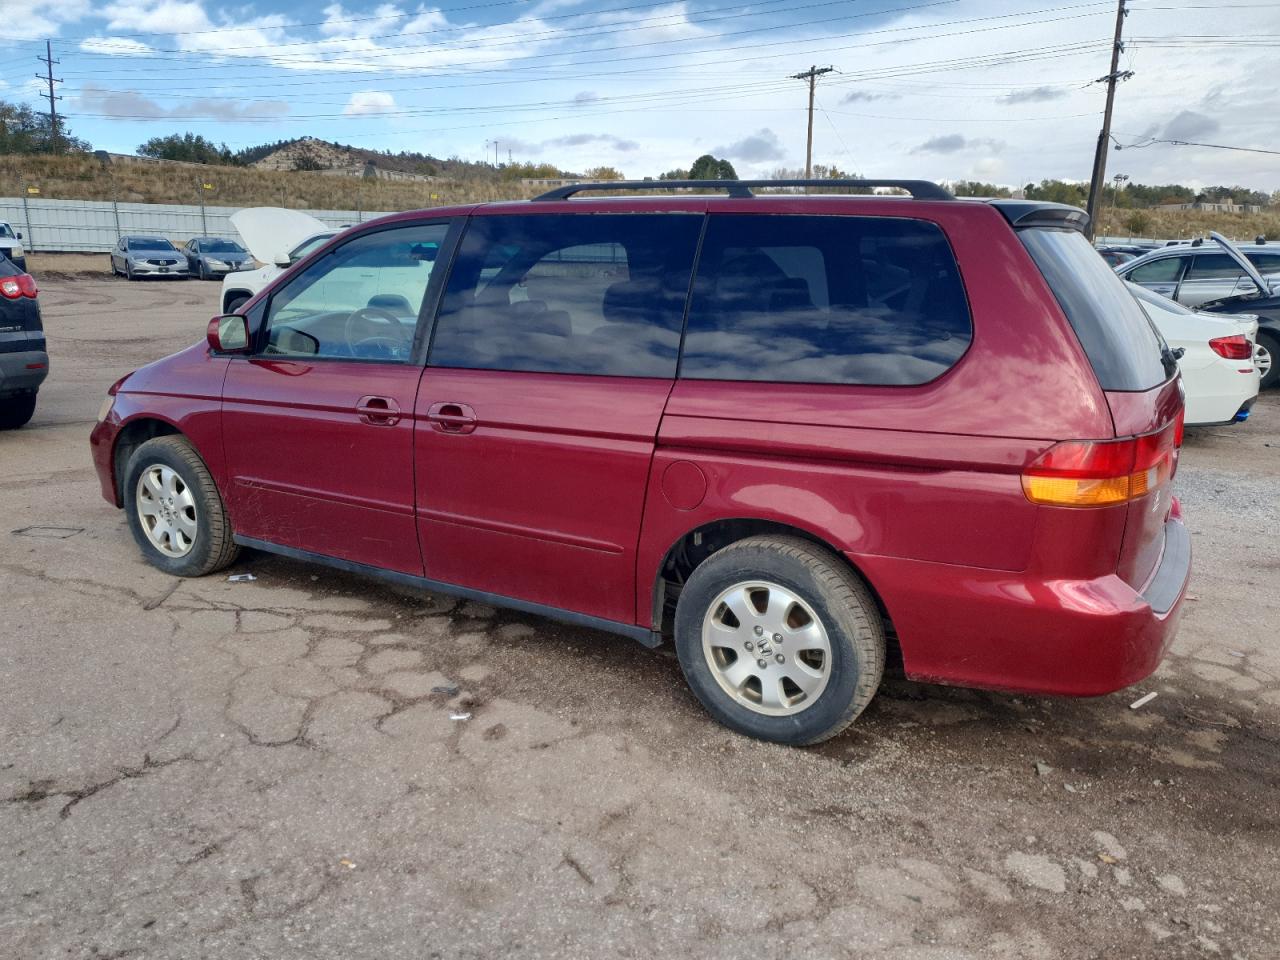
xmin=703 ymin=581 xmax=832 ymax=717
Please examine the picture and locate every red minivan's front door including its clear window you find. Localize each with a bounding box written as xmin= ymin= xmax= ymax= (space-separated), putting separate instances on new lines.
xmin=223 ymin=223 xmax=448 ymax=576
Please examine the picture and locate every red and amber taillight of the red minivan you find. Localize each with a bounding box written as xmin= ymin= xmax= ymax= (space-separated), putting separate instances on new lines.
xmin=1023 ymin=417 xmax=1181 ymax=507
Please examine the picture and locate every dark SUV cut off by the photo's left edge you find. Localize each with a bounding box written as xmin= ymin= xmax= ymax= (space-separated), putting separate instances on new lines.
xmin=0 ymin=256 xmax=49 ymax=430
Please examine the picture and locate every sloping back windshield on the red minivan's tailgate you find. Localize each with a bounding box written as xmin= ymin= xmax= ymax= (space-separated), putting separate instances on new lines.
xmin=1019 ymin=228 xmax=1170 ymax=390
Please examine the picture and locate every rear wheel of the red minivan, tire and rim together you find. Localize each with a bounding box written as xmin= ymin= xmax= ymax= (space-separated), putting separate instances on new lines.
xmin=676 ymin=536 xmax=884 ymax=746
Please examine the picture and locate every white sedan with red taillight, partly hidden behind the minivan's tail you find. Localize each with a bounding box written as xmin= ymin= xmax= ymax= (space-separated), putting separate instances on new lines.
xmin=1125 ymin=283 xmax=1262 ymax=426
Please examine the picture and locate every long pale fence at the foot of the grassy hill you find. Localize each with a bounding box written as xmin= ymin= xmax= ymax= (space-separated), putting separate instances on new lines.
xmin=0 ymin=197 xmax=392 ymax=253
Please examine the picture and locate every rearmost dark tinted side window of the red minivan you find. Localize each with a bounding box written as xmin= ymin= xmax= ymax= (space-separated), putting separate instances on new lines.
xmin=680 ymin=215 xmax=967 ymax=384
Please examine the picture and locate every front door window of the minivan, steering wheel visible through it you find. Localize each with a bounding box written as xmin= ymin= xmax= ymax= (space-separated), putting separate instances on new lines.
xmin=261 ymin=223 xmax=448 ymax=364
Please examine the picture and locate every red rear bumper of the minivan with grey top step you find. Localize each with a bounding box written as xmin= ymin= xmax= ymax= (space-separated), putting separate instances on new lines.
xmin=850 ymin=518 xmax=1190 ymax=696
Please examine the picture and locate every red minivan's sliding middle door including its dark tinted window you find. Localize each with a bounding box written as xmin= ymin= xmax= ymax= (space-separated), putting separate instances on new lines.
xmin=416 ymin=214 xmax=703 ymax=623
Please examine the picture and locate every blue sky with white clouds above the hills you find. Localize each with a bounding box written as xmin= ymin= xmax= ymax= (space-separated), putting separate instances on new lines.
xmin=0 ymin=0 xmax=1280 ymax=191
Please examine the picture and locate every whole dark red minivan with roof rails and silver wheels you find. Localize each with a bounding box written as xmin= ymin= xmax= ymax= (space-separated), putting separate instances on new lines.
xmin=92 ymin=180 xmax=1190 ymax=744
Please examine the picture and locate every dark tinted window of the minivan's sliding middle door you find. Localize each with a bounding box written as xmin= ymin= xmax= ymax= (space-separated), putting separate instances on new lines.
xmin=429 ymin=214 xmax=703 ymax=378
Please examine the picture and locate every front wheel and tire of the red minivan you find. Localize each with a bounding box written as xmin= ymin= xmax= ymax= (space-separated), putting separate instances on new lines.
xmin=123 ymin=436 xmax=239 ymax=577
